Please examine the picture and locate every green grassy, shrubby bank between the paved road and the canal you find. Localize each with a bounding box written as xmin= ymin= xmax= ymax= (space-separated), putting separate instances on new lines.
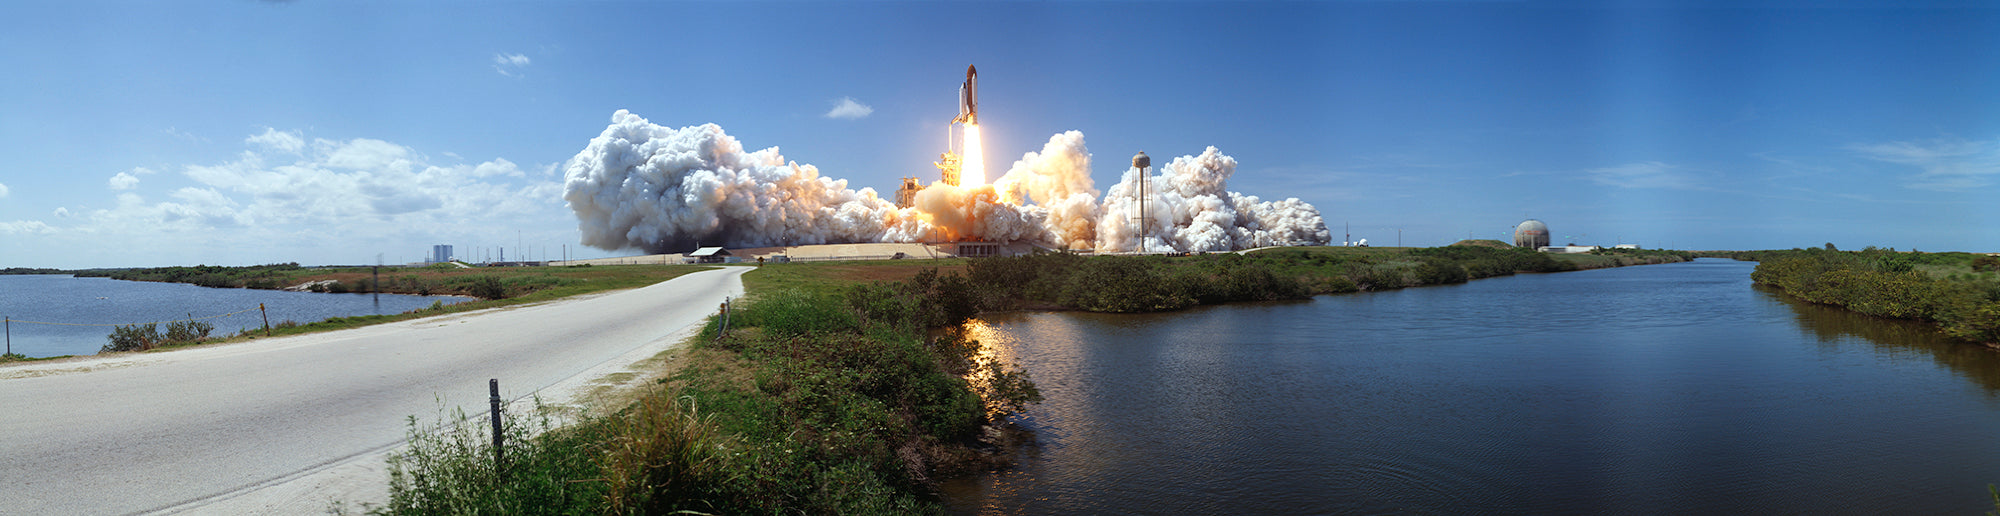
xmin=374 ymin=266 xmax=1040 ymax=514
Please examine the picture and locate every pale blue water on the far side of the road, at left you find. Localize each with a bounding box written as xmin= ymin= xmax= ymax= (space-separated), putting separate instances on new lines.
xmin=0 ymin=276 xmax=470 ymax=356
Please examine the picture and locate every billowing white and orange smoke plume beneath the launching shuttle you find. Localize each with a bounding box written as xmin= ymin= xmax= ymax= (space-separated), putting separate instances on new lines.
xmin=562 ymin=110 xmax=1332 ymax=252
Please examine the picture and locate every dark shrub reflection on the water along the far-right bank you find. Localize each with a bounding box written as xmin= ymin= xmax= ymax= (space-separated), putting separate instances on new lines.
xmin=1756 ymin=286 xmax=2000 ymax=400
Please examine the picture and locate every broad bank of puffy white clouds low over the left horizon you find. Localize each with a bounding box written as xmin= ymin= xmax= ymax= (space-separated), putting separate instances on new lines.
xmin=54 ymin=128 xmax=562 ymax=260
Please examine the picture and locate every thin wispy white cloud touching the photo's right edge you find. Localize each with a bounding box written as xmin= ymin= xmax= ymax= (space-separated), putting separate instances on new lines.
xmin=1848 ymin=138 xmax=2000 ymax=192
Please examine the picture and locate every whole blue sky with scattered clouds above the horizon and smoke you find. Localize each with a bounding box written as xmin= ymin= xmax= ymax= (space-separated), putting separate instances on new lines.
xmin=0 ymin=0 xmax=2000 ymax=268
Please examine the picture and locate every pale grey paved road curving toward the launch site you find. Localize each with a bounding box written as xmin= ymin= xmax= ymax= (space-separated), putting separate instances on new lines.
xmin=0 ymin=268 xmax=746 ymax=514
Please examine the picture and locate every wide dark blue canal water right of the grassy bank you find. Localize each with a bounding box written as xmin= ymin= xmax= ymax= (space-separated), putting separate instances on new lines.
xmin=942 ymin=258 xmax=2000 ymax=514
